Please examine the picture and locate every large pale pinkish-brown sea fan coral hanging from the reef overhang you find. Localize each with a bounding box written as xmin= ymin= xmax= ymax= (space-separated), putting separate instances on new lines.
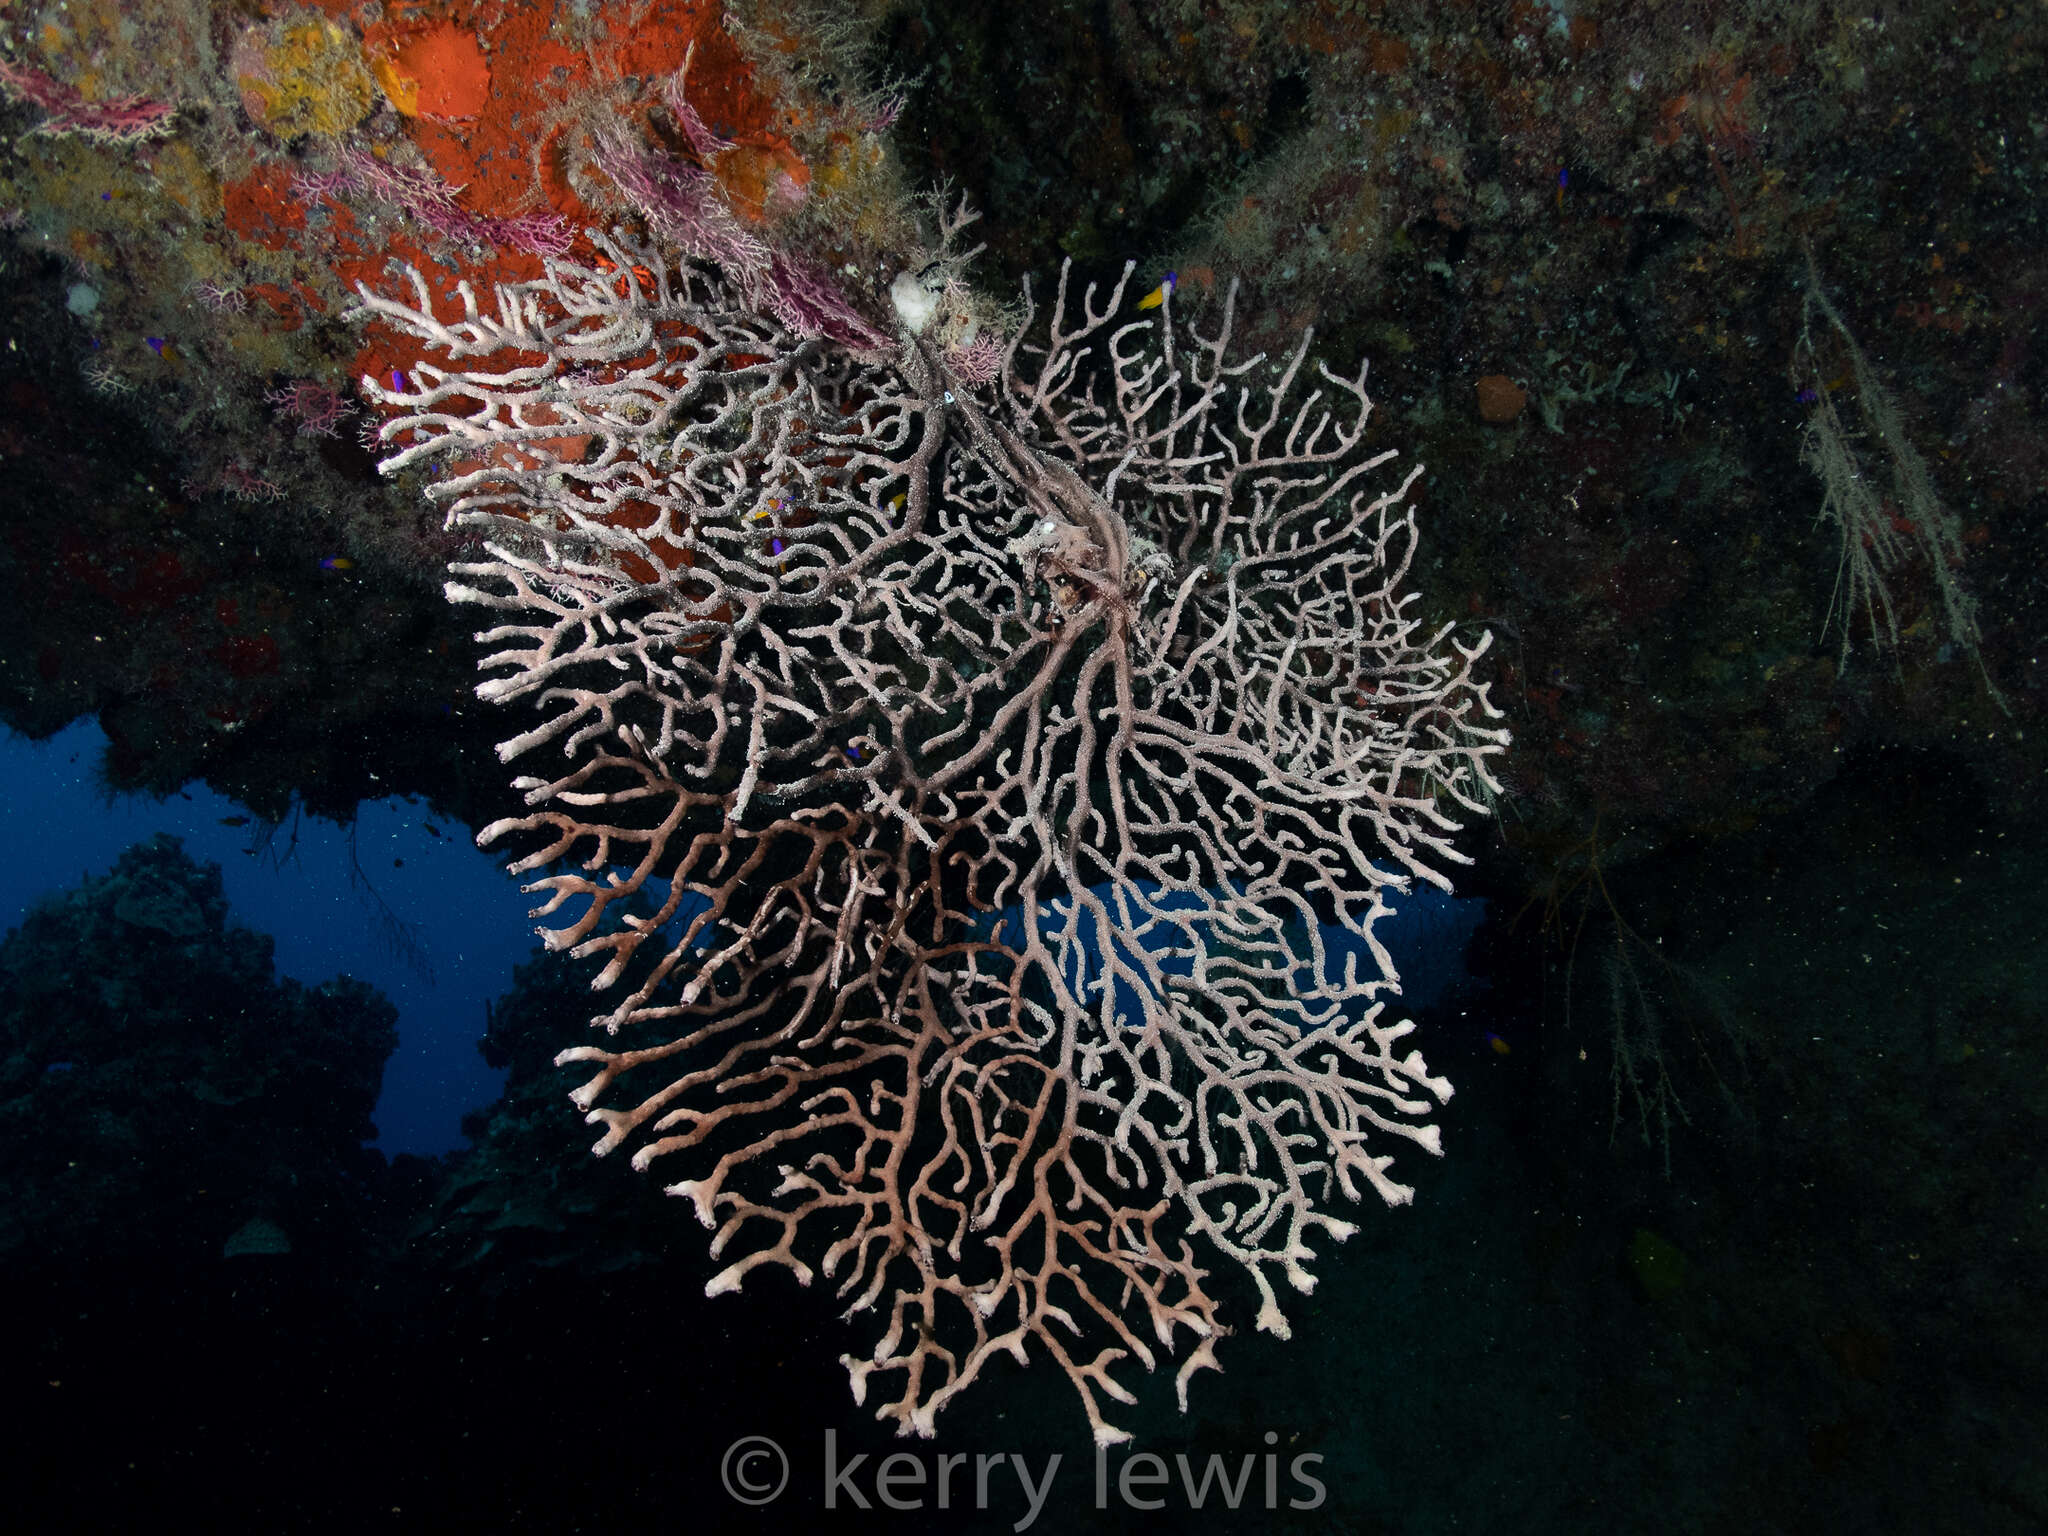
xmin=358 ymin=201 xmax=1507 ymax=1444
